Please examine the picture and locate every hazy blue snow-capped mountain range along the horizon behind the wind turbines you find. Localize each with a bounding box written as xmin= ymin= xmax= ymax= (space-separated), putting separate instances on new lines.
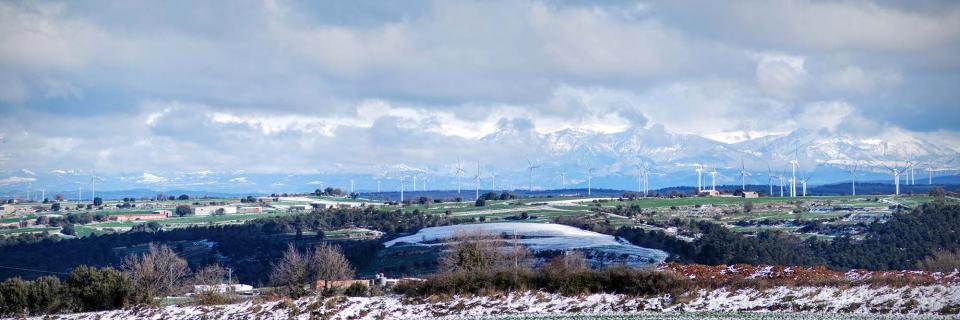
xmin=0 ymin=124 xmax=960 ymax=195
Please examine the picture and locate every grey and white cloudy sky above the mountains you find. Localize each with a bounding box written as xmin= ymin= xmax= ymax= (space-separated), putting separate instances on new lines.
xmin=0 ymin=0 xmax=960 ymax=172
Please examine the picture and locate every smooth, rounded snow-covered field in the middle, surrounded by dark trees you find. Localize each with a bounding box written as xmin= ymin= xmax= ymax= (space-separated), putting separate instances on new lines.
xmin=384 ymin=222 xmax=667 ymax=266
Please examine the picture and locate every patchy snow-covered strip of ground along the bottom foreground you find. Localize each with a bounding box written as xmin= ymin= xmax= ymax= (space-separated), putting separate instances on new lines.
xmin=36 ymin=285 xmax=960 ymax=320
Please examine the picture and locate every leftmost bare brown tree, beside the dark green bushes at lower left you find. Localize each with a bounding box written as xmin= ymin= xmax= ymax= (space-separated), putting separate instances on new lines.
xmin=121 ymin=243 xmax=190 ymax=298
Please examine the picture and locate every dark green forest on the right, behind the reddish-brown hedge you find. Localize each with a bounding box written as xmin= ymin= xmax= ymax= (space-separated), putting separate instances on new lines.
xmin=616 ymin=202 xmax=960 ymax=270
